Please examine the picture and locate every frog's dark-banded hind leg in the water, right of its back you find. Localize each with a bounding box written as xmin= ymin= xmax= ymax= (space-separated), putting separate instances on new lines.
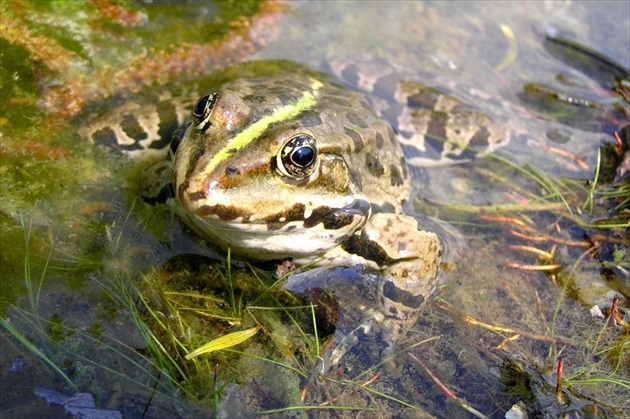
xmin=329 ymin=56 xmax=515 ymax=167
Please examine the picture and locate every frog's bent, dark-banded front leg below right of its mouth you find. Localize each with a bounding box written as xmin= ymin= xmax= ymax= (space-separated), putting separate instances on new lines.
xmin=331 ymin=213 xmax=441 ymax=364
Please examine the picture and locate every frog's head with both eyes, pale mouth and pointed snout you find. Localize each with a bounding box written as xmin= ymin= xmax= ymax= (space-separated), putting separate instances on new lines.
xmin=172 ymin=77 xmax=371 ymax=259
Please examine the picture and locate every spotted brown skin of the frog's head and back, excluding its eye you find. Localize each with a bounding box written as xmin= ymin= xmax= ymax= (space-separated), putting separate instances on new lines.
xmin=173 ymin=73 xmax=410 ymax=263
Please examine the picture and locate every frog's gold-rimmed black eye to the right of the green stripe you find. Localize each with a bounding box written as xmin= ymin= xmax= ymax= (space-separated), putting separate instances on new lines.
xmin=276 ymin=134 xmax=317 ymax=179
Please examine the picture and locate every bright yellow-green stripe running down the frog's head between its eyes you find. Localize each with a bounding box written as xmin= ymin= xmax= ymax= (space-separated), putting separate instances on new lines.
xmin=203 ymin=79 xmax=324 ymax=175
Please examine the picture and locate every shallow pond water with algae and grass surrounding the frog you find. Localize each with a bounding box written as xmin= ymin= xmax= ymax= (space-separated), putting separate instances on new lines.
xmin=0 ymin=1 xmax=630 ymax=417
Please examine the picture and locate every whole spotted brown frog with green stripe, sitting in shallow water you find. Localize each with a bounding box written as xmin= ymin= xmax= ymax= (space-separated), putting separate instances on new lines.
xmin=83 ymin=61 xmax=506 ymax=365
